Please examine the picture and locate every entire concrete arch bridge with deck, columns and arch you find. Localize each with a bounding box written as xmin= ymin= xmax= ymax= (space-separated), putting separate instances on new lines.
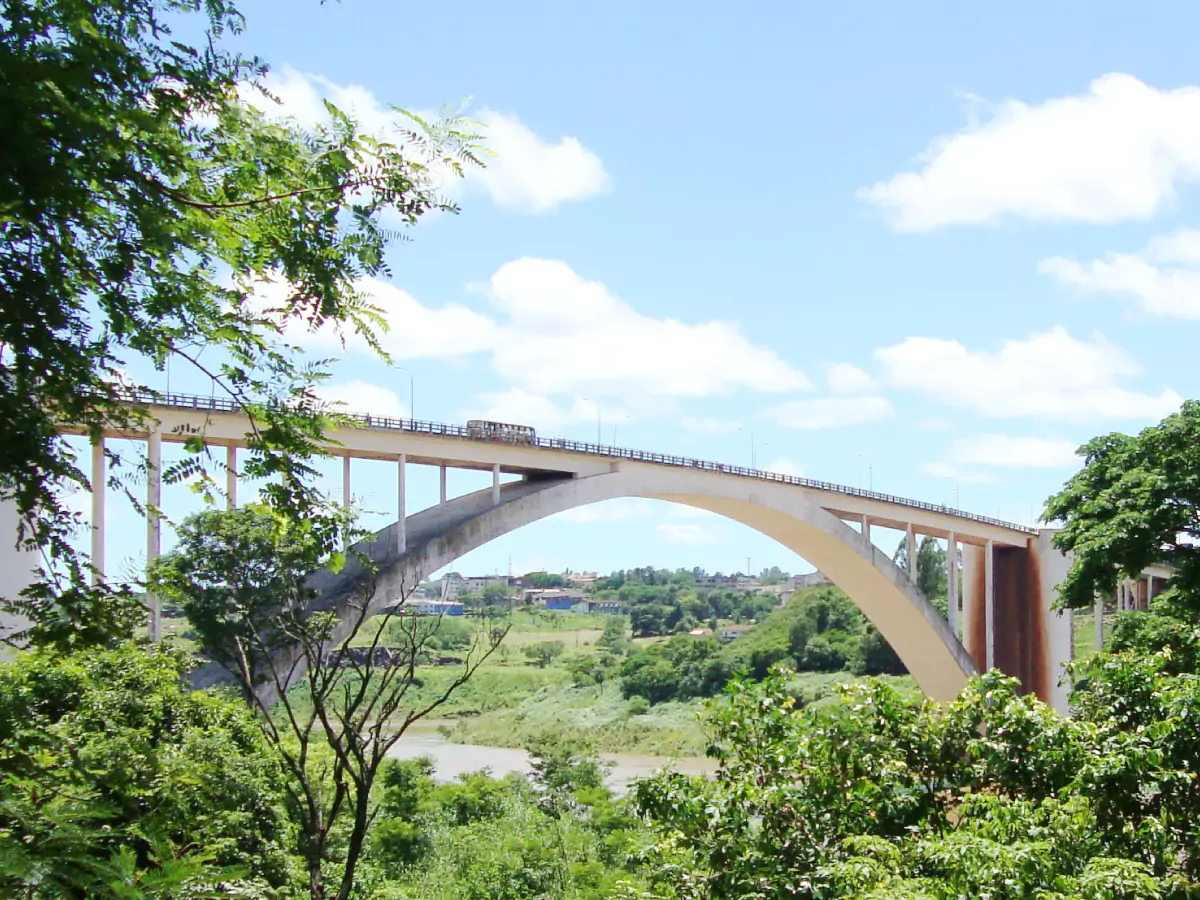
xmin=63 ymin=394 xmax=1070 ymax=708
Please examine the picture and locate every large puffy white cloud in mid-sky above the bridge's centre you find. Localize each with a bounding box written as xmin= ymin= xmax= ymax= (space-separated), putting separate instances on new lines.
xmin=486 ymin=258 xmax=809 ymax=402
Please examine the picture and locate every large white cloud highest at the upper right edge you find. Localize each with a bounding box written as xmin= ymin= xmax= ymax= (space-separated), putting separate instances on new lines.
xmin=858 ymin=73 xmax=1200 ymax=232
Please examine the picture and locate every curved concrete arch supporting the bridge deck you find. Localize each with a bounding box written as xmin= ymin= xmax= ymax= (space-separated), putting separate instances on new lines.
xmin=313 ymin=464 xmax=977 ymax=701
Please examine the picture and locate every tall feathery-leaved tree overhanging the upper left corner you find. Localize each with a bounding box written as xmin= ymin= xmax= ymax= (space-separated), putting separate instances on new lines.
xmin=0 ymin=0 xmax=476 ymax=647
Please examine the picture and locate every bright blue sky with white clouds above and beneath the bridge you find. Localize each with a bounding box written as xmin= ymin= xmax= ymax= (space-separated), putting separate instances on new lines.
xmin=77 ymin=0 xmax=1200 ymax=572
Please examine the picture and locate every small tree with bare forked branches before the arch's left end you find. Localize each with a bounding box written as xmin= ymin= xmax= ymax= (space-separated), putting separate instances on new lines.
xmin=151 ymin=505 xmax=504 ymax=900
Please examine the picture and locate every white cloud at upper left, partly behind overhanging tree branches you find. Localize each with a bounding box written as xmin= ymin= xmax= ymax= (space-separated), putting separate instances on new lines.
xmin=254 ymin=67 xmax=611 ymax=212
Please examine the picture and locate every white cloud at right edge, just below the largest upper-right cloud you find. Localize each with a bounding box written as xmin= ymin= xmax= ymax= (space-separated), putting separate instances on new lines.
xmin=1038 ymin=228 xmax=1200 ymax=319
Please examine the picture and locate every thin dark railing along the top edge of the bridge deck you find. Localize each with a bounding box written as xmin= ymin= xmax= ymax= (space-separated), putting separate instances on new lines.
xmin=128 ymin=390 xmax=1037 ymax=534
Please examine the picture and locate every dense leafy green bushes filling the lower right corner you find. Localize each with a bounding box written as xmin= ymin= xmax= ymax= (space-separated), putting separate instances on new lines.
xmin=636 ymin=655 xmax=1200 ymax=900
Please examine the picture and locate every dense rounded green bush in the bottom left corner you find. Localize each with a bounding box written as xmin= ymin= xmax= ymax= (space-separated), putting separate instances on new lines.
xmin=0 ymin=646 xmax=293 ymax=899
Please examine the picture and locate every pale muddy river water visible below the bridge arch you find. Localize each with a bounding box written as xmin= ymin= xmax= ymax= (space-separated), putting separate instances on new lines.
xmin=390 ymin=728 xmax=716 ymax=793
